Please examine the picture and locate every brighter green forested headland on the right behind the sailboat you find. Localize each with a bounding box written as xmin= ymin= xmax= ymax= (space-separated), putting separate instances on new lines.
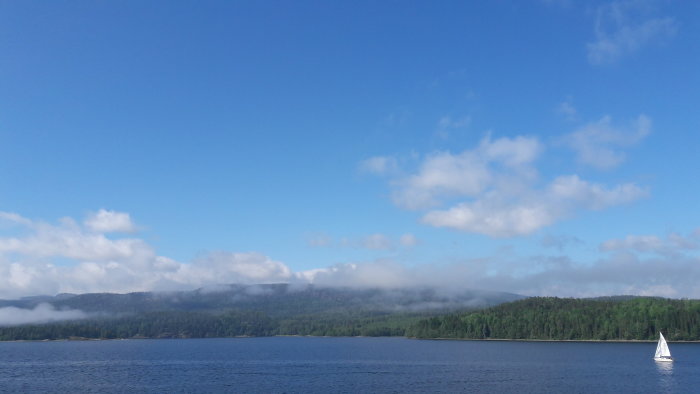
xmin=406 ymin=297 xmax=700 ymax=341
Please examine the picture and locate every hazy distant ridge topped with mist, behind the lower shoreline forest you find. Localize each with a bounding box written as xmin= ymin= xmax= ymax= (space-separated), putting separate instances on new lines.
xmin=0 ymin=284 xmax=523 ymax=315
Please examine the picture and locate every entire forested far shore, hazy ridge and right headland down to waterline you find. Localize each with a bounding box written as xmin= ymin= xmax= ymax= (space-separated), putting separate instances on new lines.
xmin=5 ymin=286 xmax=700 ymax=340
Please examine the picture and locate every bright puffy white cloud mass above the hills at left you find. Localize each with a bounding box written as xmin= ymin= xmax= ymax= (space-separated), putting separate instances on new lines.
xmin=0 ymin=213 xmax=300 ymax=298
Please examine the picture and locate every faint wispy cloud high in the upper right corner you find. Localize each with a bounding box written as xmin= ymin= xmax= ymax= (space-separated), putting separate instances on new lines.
xmin=587 ymin=0 xmax=678 ymax=65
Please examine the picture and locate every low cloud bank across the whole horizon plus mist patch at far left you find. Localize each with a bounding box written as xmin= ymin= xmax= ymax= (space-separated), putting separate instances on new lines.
xmin=0 ymin=212 xmax=700 ymax=300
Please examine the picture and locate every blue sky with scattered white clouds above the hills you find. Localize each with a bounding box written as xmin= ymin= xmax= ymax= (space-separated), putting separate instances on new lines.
xmin=0 ymin=0 xmax=700 ymax=298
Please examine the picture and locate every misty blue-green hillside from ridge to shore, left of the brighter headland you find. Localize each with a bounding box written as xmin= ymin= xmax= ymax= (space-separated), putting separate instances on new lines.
xmin=0 ymin=284 xmax=520 ymax=340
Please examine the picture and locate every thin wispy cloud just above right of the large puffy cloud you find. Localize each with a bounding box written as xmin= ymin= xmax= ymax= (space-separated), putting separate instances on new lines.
xmin=562 ymin=115 xmax=651 ymax=169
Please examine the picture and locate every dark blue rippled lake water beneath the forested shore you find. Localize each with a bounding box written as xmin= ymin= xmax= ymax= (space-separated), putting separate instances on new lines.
xmin=0 ymin=337 xmax=700 ymax=393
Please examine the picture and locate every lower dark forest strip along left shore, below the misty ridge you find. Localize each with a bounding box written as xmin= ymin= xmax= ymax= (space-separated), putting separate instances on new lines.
xmin=0 ymin=311 xmax=426 ymax=341
